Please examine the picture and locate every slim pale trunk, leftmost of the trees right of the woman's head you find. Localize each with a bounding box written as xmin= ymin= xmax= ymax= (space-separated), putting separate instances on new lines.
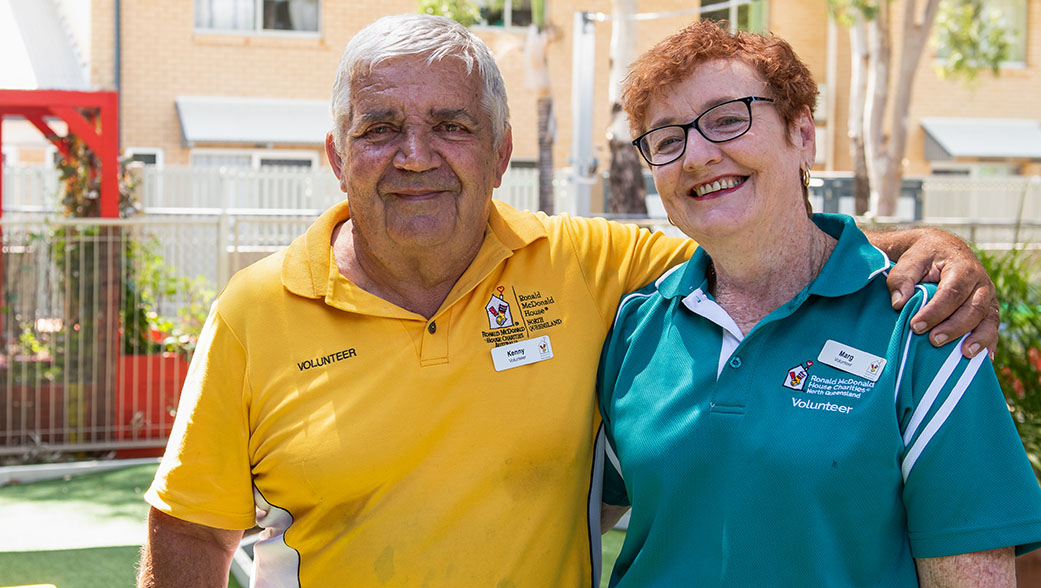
xmin=848 ymin=11 xmax=871 ymax=214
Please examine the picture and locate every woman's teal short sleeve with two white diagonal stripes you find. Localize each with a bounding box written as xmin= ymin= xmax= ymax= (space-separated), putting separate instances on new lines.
xmin=897 ymin=293 xmax=1041 ymax=558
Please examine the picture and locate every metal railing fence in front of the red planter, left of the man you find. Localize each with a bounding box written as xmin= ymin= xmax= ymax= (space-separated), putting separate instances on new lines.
xmin=0 ymin=219 xmax=207 ymax=461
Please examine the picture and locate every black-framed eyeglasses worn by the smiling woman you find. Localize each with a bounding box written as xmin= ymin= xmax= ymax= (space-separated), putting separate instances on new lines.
xmin=633 ymin=96 xmax=773 ymax=165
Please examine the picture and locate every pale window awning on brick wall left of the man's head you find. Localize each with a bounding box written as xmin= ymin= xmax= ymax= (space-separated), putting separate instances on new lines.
xmin=174 ymin=96 xmax=332 ymax=147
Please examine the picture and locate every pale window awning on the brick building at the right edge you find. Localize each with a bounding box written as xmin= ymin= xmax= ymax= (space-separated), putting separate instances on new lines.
xmin=921 ymin=118 xmax=1041 ymax=161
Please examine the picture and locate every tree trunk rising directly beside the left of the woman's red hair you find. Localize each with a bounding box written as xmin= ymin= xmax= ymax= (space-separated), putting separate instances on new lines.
xmin=607 ymin=0 xmax=648 ymax=215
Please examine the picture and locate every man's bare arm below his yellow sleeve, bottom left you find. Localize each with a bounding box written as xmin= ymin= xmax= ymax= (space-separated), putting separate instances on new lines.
xmin=137 ymin=508 xmax=243 ymax=588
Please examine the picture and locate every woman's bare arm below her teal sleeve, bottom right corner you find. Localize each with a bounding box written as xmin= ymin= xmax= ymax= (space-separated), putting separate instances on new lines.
xmin=915 ymin=547 xmax=1016 ymax=588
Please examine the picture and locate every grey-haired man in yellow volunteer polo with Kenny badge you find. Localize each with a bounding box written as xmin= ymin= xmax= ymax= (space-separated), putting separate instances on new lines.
xmin=138 ymin=15 xmax=994 ymax=588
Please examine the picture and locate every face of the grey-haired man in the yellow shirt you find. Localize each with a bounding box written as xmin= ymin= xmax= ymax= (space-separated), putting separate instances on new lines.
xmin=327 ymin=57 xmax=512 ymax=259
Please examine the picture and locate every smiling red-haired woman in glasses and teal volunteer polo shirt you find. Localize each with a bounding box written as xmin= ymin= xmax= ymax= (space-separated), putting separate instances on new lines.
xmin=599 ymin=22 xmax=1041 ymax=587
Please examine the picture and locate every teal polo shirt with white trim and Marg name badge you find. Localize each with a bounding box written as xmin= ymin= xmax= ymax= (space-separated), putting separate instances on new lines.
xmin=598 ymin=214 xmax=1041 ymax=588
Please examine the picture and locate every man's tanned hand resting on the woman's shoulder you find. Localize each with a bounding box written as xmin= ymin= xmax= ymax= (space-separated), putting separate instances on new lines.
xmin=867 ymin=228 xmax=1000 ymax=358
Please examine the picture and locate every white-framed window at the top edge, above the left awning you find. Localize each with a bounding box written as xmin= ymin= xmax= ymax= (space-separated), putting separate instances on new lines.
xmin=195 ymin=0 xmax=319 ymax=32
